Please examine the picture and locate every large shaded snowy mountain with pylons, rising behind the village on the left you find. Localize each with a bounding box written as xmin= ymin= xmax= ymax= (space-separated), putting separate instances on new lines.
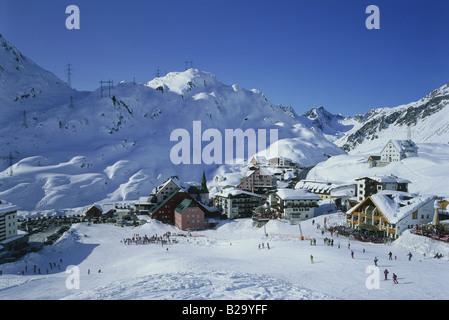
xmin=0 ymin=38 xmax=344 ymax=210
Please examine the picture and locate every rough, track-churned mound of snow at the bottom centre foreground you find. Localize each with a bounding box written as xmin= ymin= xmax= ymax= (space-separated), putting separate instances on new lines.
xmin=60 ymin=271 xmax=332 ymax=300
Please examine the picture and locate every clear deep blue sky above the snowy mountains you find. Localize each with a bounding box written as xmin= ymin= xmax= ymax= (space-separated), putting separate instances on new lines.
xmin=0 ymin=0 xmax=449 ymax=115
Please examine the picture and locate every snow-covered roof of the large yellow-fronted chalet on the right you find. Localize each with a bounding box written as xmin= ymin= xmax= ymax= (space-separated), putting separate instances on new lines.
xmin=347 ymin=190 xmax=435 ymax=223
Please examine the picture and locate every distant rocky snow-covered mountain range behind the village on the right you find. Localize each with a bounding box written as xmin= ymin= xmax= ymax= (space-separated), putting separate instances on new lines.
xmin=302 ymin=83 xmax=449 ymax=154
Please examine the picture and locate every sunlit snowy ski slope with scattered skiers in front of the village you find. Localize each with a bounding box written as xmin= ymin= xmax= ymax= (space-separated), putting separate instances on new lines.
xmin=0 ymin=214 xmax=449 ymax=300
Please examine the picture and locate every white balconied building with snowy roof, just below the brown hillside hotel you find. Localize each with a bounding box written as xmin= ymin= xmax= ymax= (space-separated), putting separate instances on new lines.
xmin=274 ymin=189 xmax=321 ymax=221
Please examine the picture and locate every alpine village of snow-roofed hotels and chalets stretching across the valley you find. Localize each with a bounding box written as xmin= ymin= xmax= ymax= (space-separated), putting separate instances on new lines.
xmin=0 ymin=140 xmax=449 ymax=261
